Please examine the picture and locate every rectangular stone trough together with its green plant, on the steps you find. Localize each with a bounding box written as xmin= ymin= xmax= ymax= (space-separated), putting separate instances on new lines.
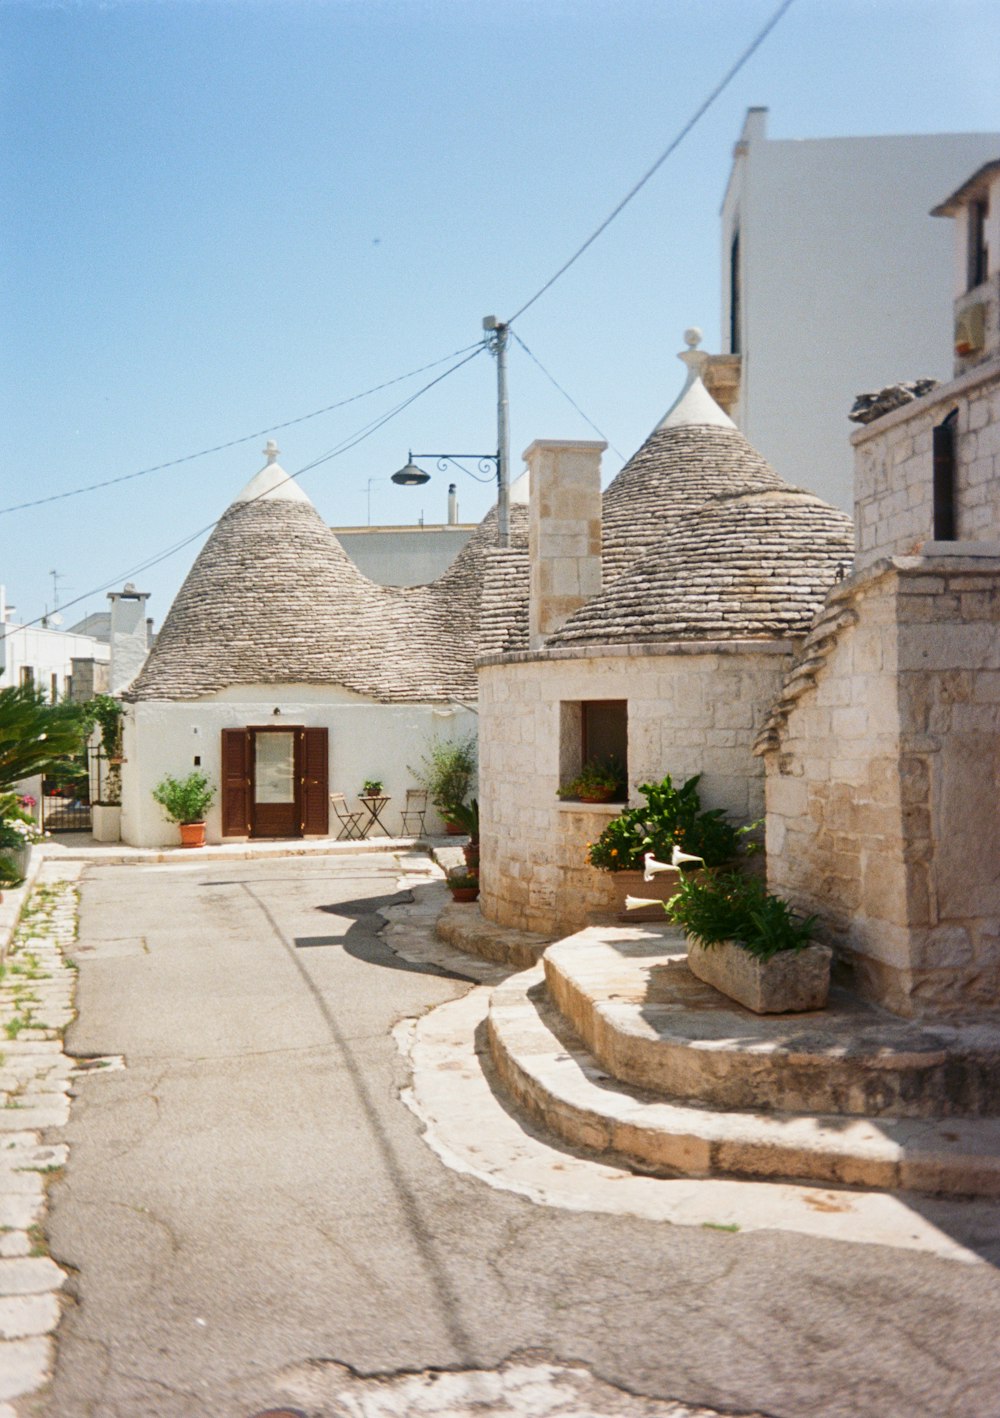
xmin=646 ymin=872 xmax=833 ymax=1014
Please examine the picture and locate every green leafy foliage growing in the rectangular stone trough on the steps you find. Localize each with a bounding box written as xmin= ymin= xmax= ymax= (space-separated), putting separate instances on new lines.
xmin=665 ymin=872 xmax=817 ymax=960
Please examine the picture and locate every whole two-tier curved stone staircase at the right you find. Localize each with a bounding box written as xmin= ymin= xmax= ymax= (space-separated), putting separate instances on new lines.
xmin=476 ymin=925 xmax=1000 ymax=1195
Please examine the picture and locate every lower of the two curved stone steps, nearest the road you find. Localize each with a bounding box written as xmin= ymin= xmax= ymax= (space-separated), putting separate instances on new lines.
xmin=488 ymin=966 xmax=1000 ymax=1197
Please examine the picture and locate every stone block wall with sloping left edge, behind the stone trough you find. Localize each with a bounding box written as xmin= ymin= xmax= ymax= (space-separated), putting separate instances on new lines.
xmin=766 ymin=557 xmax=1000 ymax=1015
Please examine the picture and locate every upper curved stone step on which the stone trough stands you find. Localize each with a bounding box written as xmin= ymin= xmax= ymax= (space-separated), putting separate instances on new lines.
xmin=545 ymin=925 xmax=1000 ymax=1119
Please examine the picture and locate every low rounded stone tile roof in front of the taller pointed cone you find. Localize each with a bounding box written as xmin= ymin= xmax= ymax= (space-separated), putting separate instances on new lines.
xmin=548 ymin=484 xmax=854 ymax=647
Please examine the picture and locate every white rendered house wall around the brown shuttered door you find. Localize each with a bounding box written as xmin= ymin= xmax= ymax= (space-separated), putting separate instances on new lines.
xmin=122 ymin=685 xmax=477 ymax=847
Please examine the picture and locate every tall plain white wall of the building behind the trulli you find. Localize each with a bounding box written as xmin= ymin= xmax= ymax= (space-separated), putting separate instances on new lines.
xmin=721 ymin=109 xmax=1000 ymax=510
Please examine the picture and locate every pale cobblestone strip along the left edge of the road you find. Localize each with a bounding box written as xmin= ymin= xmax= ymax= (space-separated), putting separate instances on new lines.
xmin=0 ymin=864 xmax=78 ymax=1418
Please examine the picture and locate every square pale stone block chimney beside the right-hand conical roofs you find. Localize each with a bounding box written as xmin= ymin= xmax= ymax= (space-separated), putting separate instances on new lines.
xmin=523 ymin=440 xmax=607 ymax=649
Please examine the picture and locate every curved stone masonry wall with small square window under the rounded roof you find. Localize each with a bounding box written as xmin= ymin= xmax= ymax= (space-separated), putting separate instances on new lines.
xmin=479 ymin=641 xmax=790 ymax=934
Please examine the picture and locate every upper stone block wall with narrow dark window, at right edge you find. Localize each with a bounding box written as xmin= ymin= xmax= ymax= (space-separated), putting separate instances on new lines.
xmin=851 ymin=360 xmax=1000 ymax=570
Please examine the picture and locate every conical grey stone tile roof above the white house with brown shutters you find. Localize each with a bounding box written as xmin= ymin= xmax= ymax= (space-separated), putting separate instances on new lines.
xmin=129 ymin=468 xmax=528 ymax=703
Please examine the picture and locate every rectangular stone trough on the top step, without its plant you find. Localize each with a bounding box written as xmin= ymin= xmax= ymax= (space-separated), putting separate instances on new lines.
xmin=688 ymin=940 xmax=833 ymax=1014
